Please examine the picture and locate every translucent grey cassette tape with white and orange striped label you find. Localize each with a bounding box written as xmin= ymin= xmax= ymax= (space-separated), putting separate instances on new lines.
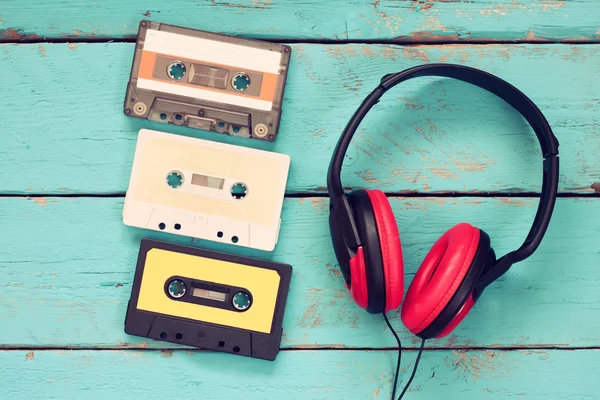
xmin=124 ymin=21 xmax=291 ymax=141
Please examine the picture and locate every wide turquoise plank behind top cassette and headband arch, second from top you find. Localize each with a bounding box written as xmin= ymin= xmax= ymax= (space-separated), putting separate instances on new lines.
xmin=0 ymin=42 xmax=600 ymax=193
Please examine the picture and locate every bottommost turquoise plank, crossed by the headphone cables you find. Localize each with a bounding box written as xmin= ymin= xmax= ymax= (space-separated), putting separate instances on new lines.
xmin=0 ymin=350 xmax=600 ymax=400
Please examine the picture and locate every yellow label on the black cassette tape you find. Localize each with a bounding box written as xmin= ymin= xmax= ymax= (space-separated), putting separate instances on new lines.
xmin=137 ymin=248 xmax=281 ymax=333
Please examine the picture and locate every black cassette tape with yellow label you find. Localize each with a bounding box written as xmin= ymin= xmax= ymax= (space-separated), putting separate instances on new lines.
xmin=125 ymin=239 xmax=292 ymax=360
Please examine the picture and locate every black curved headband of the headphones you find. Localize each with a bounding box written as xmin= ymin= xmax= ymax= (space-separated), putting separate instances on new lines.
xmin=327 ymin=64 xmax=559 ymax=295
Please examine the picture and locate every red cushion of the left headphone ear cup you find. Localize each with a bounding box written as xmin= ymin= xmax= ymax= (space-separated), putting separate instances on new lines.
xmin=366 ymin=189 xmax=404 ymax=312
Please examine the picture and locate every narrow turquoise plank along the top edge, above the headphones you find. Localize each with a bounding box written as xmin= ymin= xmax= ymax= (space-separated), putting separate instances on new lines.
xmin=0 ymin=0 xmax=600 ymax=42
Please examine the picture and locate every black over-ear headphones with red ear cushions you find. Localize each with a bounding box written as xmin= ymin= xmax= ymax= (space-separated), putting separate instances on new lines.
xmin=327 ymin=64 xmax=559 ymax=340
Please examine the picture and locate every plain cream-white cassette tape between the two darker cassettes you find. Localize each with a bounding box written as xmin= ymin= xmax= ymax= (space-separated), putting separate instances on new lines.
xmin=123 ymin=129 xmax=290 ymax=251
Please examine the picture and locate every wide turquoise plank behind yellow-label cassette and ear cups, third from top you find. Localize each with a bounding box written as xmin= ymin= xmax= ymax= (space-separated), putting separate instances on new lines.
xmin=0 ymin=198 xmax=600 ymax=348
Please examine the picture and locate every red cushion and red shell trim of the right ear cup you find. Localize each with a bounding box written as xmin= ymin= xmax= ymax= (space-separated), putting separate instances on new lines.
xmin=402 ymin=223 xmax=480 ymax=336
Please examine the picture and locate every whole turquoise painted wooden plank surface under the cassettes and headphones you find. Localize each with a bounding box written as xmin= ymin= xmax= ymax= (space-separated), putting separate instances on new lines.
xmin=0 ymin=0 xmax=600 ymax=400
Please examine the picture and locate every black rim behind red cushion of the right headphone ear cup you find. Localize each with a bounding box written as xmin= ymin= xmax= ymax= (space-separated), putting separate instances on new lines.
xmin=418 ymin=229 xmax=496 ymax=339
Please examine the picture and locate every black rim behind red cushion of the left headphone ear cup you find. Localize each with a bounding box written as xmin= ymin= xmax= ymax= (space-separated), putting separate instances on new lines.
xmin=348 ymin=190 xmax=385 ymax=314
